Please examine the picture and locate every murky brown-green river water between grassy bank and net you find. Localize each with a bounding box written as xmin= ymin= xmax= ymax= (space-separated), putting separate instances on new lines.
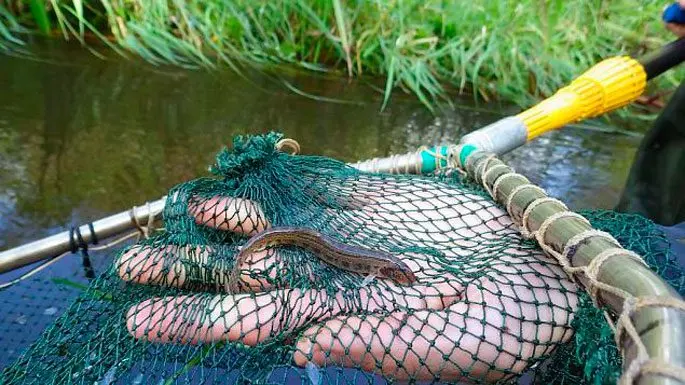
xmin=0 ymin=42 xmax=638 ymax=248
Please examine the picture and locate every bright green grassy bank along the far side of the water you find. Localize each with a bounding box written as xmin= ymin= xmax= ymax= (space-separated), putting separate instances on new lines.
xmin=0 ymin=0 xmax=674 ymax=109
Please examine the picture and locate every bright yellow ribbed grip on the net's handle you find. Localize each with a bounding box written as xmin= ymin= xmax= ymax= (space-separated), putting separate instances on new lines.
xmin=518 ymin=56 xmax=647 ymax=140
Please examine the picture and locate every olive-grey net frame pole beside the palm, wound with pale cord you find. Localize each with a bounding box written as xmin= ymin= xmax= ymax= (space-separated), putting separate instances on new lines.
xmin=451 ymin=146 xmax=685 ymax=385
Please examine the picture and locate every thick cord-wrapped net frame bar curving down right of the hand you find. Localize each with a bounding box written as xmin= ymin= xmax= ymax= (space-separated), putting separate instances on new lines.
xmin=450 ymin=145 xmax=685 ymax=385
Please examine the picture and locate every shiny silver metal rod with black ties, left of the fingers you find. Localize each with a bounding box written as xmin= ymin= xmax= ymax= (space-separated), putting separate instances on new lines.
xmin=0 ymin=198 xmax=166 ymax=273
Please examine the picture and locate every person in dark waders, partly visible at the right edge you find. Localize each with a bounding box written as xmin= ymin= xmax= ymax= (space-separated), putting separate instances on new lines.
xmin=616 ymin=0 xmax=685 ymax=260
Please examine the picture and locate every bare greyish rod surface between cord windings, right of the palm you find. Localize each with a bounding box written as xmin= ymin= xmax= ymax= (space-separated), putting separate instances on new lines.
xmin=456 ymin=149 xmax=685 ymax=385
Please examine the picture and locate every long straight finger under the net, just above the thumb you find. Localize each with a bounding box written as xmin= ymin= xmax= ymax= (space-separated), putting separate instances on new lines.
xmin=126 ymin=280 xmax=440 ymax=345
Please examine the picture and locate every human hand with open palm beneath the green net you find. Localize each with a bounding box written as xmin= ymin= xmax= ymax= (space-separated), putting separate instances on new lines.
xmin=117 ymin=176 xmax=578 ymax=381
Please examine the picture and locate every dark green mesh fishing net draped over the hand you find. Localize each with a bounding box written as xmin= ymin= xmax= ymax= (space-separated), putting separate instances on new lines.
xmin=0 ymin=133 xmax=685 ymax=385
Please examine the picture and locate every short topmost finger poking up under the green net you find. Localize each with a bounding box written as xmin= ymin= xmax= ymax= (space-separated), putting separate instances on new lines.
xmin=188 ymin=196 xmax=269 ymax=235
